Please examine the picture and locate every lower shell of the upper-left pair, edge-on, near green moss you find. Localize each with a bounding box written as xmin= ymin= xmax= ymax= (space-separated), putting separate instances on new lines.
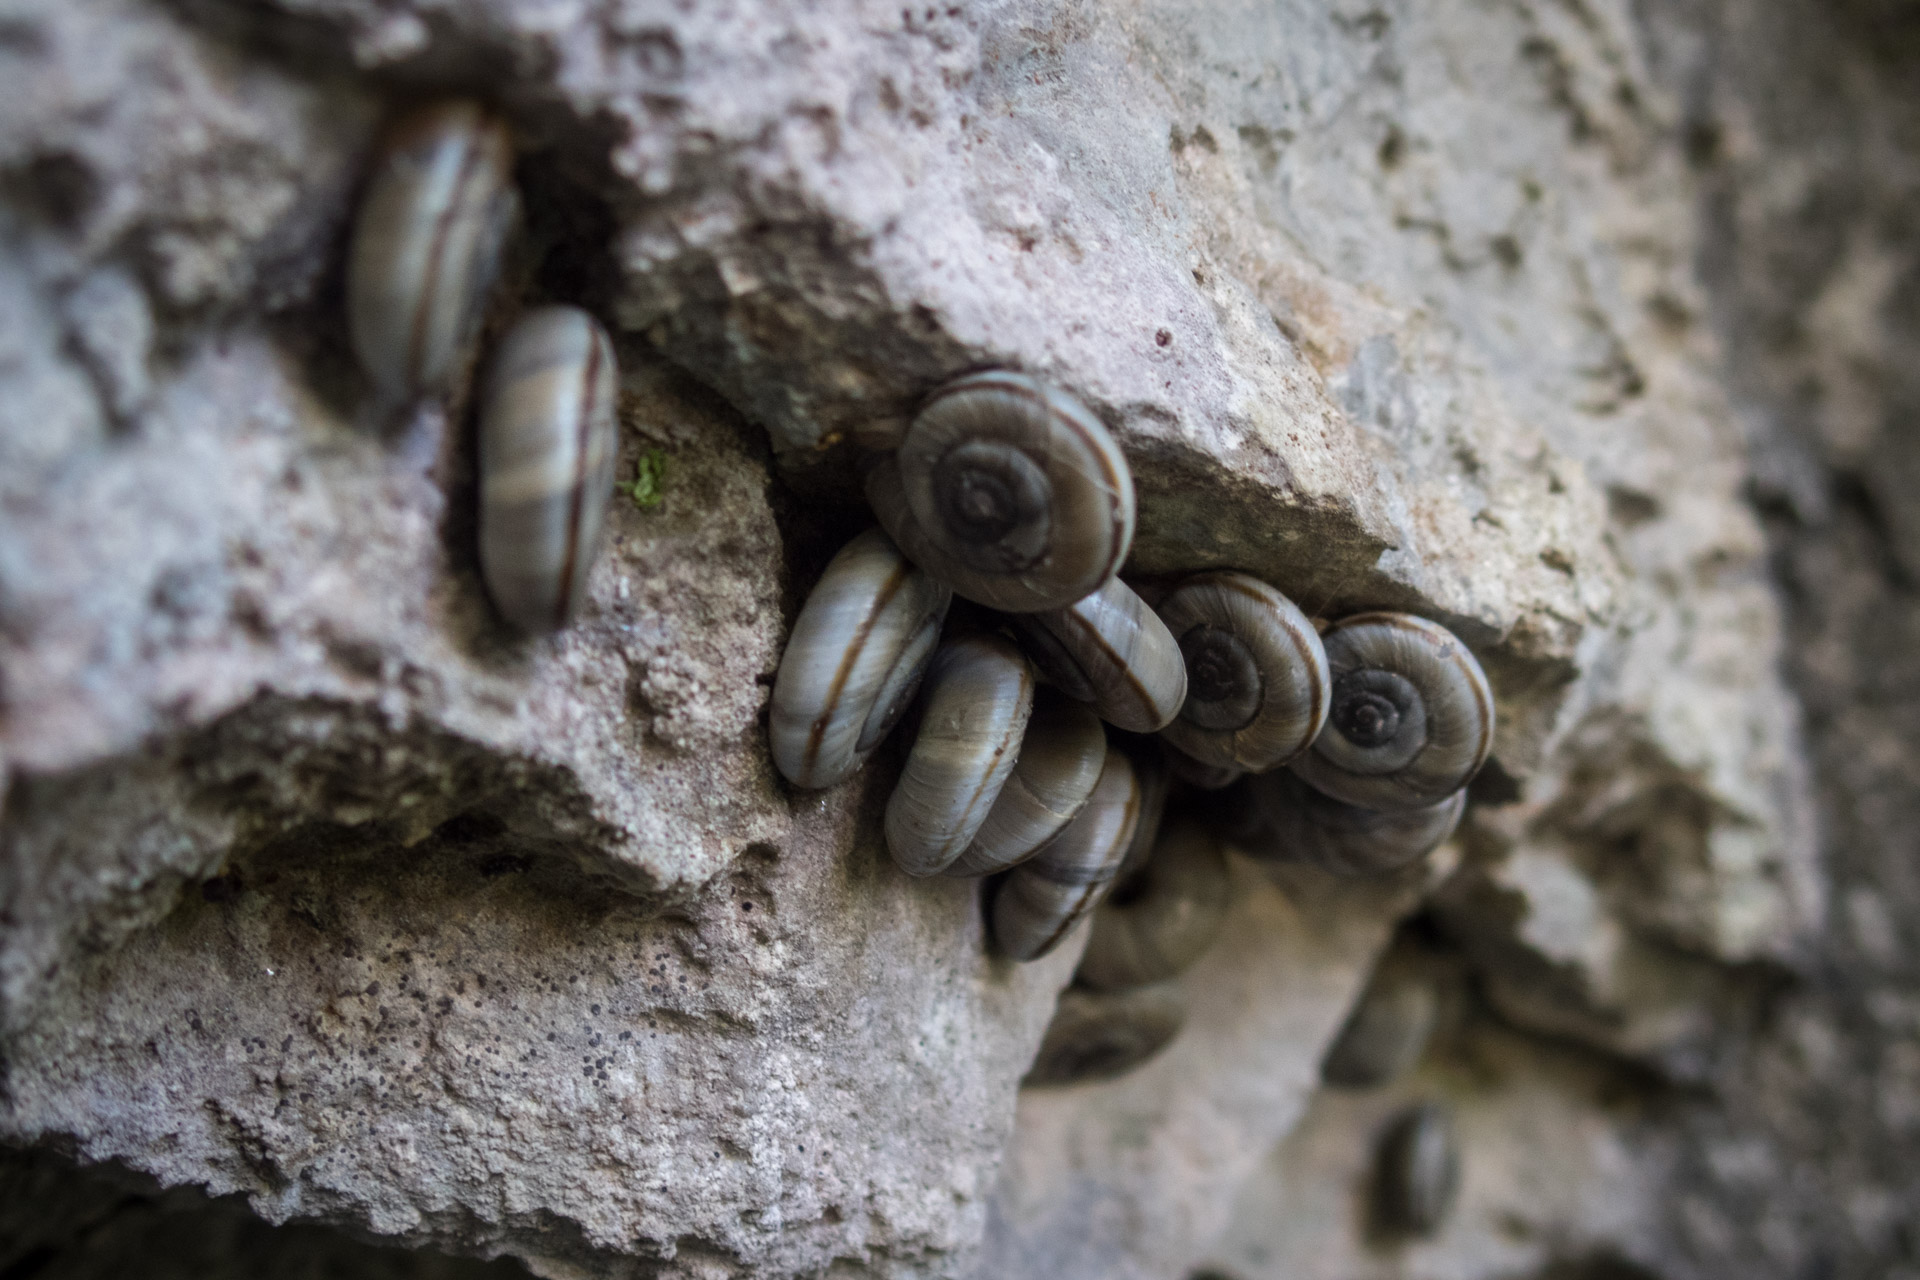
xmin=480 ymin=307 xmax=620 ymax=635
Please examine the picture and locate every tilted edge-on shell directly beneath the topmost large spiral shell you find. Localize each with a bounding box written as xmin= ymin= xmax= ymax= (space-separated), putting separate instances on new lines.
xmin=1014 ymin=578 xmax=1187 ymax=733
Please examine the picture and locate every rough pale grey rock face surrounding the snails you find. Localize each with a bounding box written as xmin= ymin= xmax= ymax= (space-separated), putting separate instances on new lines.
xmin=0 ymin=0 xmax=1896 ymax=1276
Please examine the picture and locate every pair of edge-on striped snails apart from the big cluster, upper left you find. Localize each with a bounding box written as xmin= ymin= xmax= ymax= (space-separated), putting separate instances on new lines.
xmin=348 ymin=100 xmax=618 ymax=635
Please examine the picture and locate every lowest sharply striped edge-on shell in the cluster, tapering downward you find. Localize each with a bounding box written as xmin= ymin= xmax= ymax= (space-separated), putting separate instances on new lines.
xmin=991 ymin=748 xmax=1140 ymax=960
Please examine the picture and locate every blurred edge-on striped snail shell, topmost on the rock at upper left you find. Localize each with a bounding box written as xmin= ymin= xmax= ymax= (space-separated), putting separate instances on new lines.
xmin=348 ymin=100 xmax=518 ymax=401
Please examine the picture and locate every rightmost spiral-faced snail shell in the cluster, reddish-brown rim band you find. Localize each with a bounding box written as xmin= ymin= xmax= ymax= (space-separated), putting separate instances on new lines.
xmin=1292 ymin=614 xmax=1494 ymax=810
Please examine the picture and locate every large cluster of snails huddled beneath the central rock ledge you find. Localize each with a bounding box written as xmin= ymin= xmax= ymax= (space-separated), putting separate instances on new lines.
xmin=770 ymin=370 xmax=1494 ymax=1084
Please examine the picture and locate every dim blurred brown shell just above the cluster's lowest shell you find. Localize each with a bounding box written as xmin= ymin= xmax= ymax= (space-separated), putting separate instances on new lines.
xmin=1075 ymin=819 xmax=1229 ymax=990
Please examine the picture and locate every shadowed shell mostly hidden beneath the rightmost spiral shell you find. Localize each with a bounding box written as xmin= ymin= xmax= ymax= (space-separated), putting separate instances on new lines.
xmin=1240 ymin=771 xmax=1467 ymax=875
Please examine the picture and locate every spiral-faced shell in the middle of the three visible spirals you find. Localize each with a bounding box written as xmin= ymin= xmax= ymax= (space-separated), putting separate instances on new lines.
xmin=1160 ymin=572 xmax=1329 ymax=773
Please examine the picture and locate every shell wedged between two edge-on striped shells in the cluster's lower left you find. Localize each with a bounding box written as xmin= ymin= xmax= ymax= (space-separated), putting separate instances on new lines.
xmin=947 ymin=689 xmax=1106 ymax=875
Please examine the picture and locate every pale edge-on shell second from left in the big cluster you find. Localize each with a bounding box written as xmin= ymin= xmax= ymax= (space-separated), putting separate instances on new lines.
xmin=885 ymin=635 xmax=1033 ymax=875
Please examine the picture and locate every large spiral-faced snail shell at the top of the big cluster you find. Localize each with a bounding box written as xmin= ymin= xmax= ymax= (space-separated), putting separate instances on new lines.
xmin=866 ymin=370 xmax=1133 ymax=614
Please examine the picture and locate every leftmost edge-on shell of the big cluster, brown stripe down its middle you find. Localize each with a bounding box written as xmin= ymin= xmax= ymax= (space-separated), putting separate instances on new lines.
xmin=768 ymin=530 xmax=952 ymax=787
